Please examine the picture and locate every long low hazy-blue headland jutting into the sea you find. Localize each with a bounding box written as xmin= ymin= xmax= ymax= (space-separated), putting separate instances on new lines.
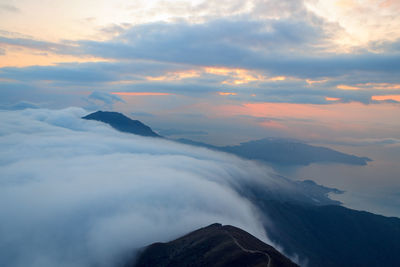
xmin=176 ymin=138 xmax=371 ymax=165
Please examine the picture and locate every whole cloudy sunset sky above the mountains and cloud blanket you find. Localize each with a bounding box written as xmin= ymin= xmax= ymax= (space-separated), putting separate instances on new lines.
xmin=0 ymin=0 xmax=400 ymax=215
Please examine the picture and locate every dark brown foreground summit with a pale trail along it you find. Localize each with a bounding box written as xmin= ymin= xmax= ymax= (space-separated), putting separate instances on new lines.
xmin=126 ymin=224 xmax=298 ymax=267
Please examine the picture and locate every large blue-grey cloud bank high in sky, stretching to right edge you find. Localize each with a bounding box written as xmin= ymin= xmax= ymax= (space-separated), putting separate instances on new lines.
xmin=71 ymin=18 xmax=400 ymax=78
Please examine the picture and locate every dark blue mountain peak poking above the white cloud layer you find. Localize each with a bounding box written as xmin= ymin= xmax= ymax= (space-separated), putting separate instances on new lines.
xmin=82 ymin=111 xmax=161 ymax=137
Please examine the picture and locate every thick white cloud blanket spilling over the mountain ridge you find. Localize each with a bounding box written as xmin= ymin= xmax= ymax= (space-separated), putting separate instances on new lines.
xmin=0 ymin=108 xmax=296 ymax=266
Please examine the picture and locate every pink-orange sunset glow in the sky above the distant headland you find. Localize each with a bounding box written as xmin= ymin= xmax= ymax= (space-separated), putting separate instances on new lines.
xmin=201 ymin=102 xmax=398 ymax=138
